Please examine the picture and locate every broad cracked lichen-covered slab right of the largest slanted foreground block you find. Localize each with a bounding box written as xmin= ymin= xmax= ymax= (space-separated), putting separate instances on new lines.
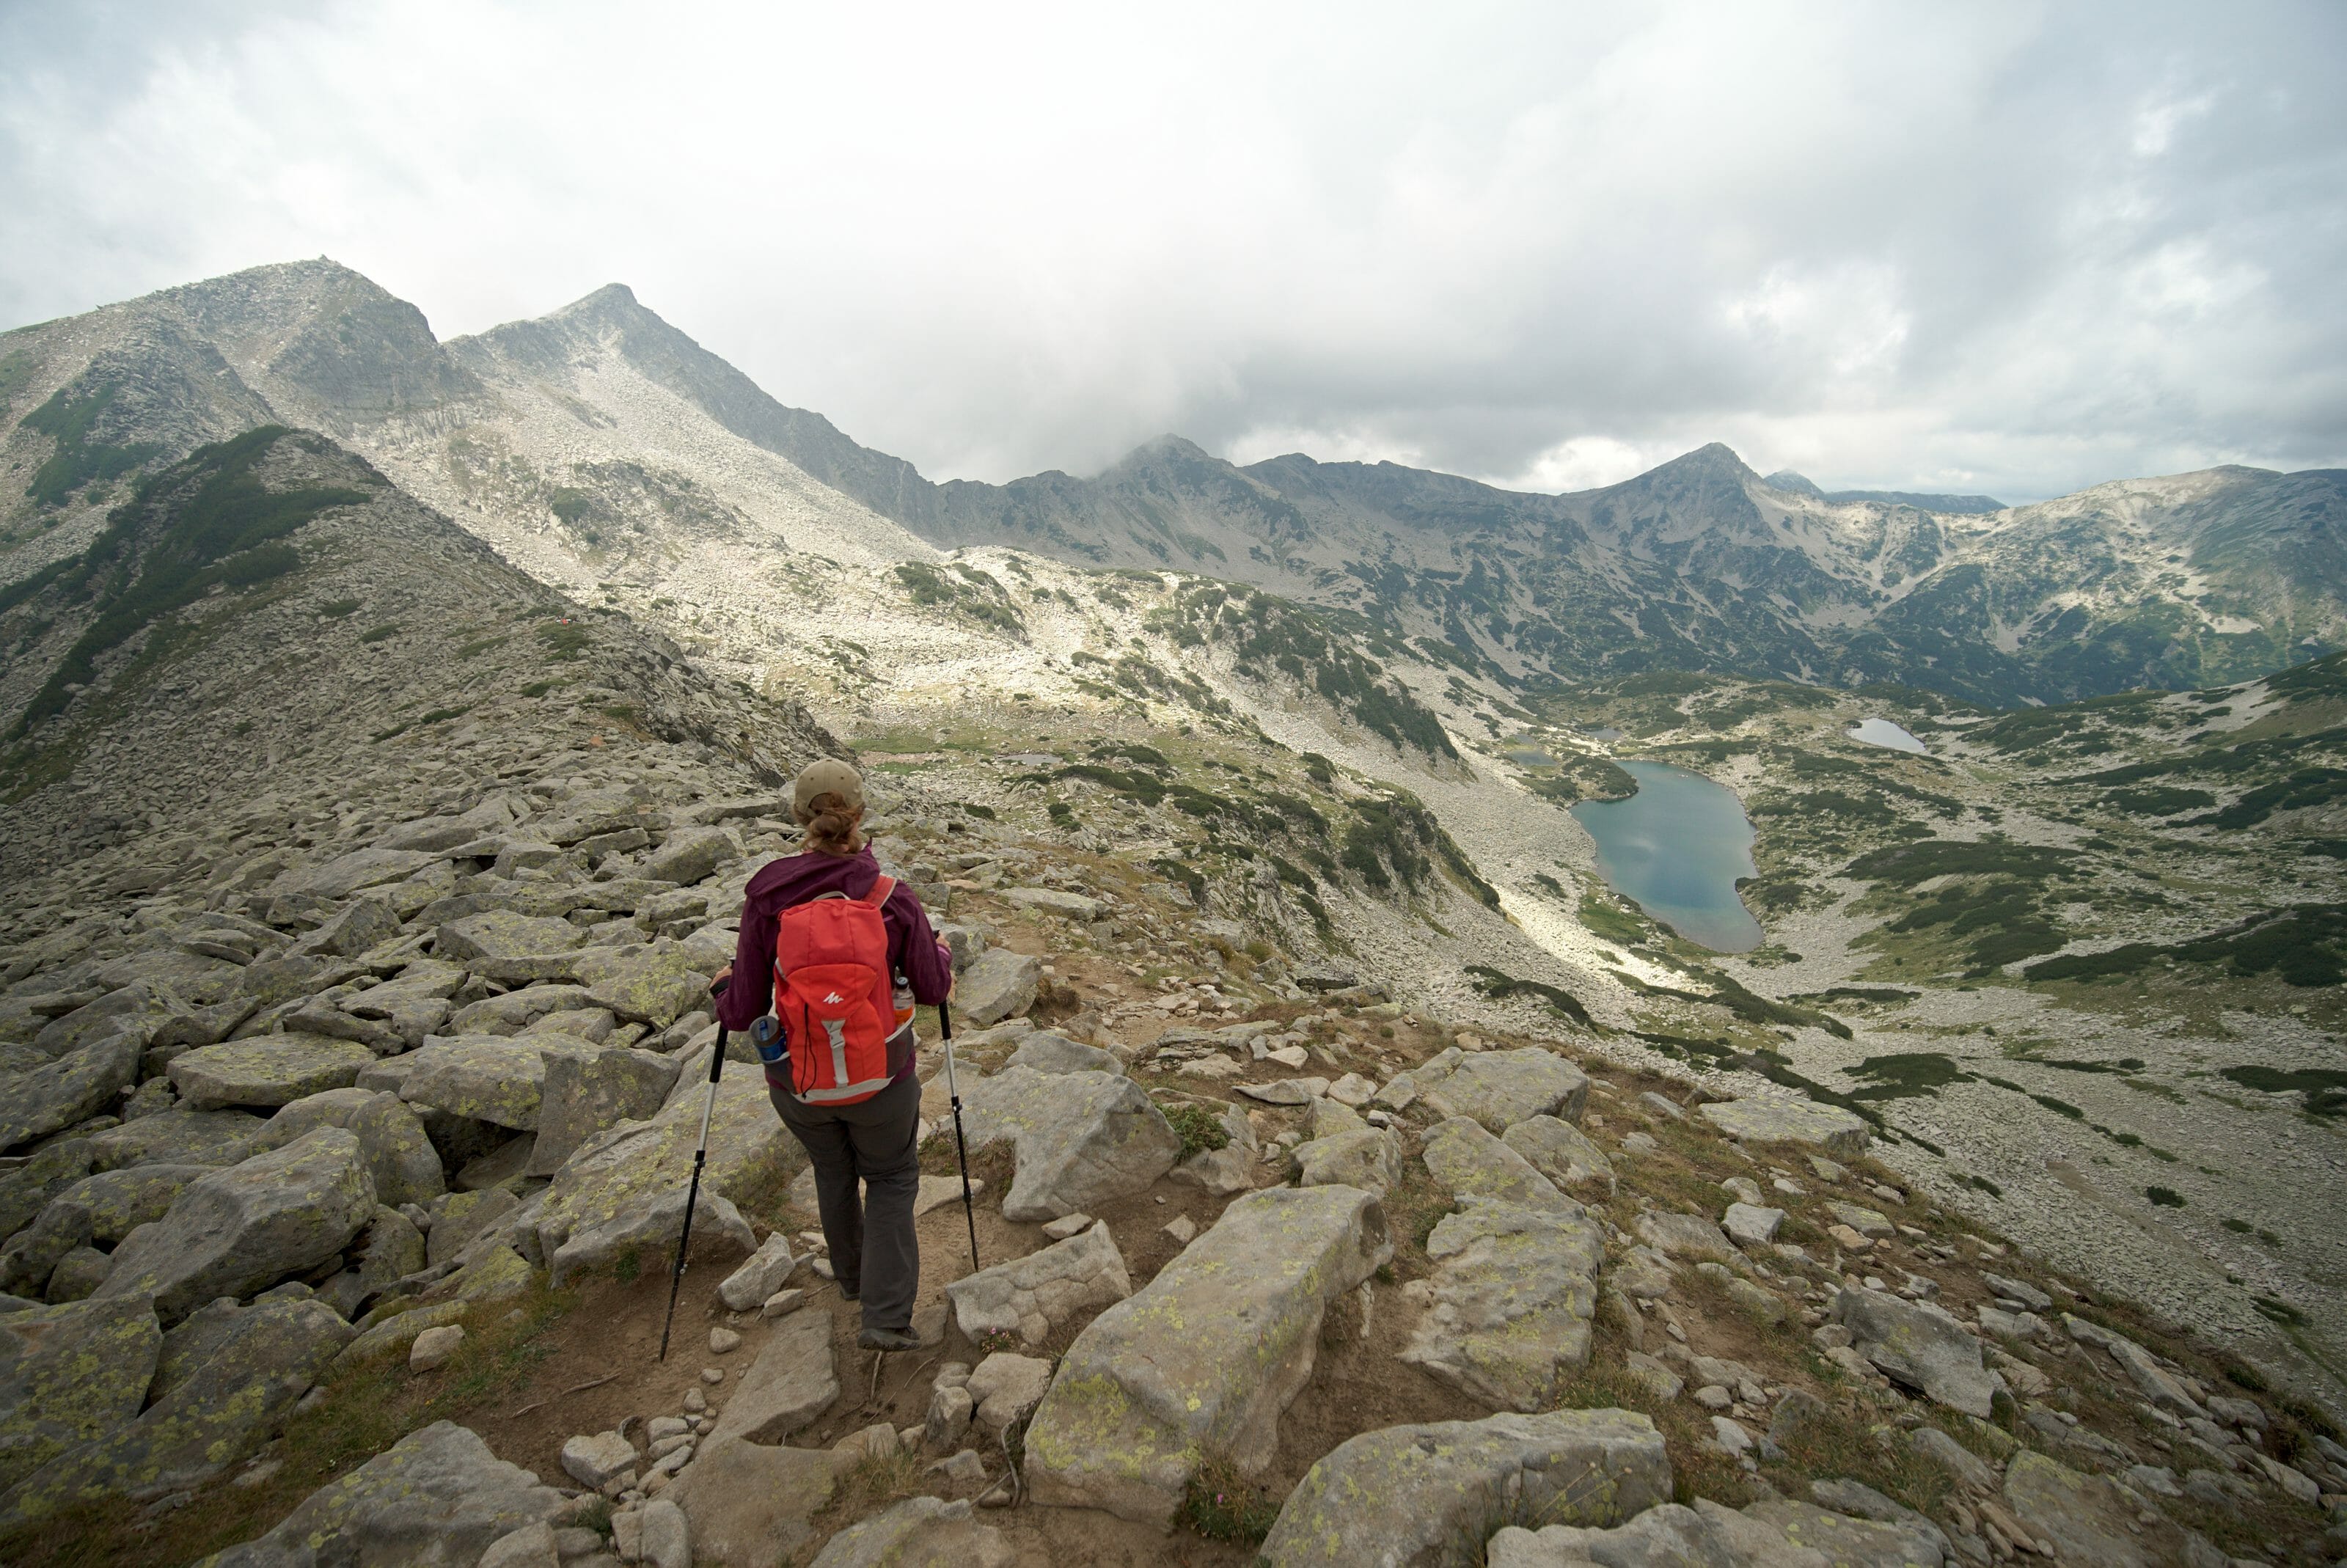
xmin=1401 ymin=1197 xmax=1605 ymax=1411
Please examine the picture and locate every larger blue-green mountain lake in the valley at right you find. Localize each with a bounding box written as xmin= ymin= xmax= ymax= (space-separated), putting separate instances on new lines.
xmin=1572 ymin=763 xmax=1760 ymax=953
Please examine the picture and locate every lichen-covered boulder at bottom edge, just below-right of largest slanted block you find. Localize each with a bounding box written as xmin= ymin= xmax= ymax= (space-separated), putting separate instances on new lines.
xmin=1263 ymin=1408 xmax=1671 ymax=1568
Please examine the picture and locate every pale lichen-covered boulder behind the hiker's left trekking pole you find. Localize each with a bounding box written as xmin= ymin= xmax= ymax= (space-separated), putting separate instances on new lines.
xmin=535 ymin=1054 xmax=808 ymax=1265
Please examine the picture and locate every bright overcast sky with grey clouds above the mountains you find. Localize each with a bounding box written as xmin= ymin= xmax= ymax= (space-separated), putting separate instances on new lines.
xmin=0 ymin=0 xmax=2347 ymax=500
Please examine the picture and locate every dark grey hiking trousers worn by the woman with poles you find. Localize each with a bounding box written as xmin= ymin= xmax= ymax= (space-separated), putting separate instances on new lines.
xmin=767 ymin=1073 xmax=920 ymax=1331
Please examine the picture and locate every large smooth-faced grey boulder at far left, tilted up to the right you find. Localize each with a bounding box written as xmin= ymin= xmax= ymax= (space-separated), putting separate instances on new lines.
xmin=98 ymin=1126 xmax=376 ymax=1322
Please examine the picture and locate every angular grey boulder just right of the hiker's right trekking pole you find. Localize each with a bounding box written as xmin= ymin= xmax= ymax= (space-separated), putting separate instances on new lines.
xmin=962 ymin=1068 xmax=1181 ymax=1220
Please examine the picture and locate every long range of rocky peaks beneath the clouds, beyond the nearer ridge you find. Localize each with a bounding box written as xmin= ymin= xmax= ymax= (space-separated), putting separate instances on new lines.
xmin=0 ymin=258 xmax=2347 ymax=706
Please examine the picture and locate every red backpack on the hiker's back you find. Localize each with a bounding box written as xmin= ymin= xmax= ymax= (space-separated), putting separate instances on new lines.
xmin=775 ymin=878 xmax=913 ymax=1105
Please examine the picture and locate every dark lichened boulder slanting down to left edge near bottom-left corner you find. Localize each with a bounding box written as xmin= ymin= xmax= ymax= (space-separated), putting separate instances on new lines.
xmin=0 ymin=1298 xmax=352 ymax=1519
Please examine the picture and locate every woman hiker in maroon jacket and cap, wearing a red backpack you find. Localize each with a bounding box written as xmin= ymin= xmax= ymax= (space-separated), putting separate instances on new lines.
xmin=711 ymin=758 xmax=953 ymax=1349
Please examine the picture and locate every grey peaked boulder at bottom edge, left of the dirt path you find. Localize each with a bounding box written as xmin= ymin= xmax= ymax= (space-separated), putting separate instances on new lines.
xmin=204 ymin=1420 xmax=571 ymax=1568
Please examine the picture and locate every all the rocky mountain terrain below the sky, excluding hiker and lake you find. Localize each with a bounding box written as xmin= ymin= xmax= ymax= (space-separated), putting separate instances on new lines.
xmin=0 ymin=263 xmax=2347 ymax=1568
